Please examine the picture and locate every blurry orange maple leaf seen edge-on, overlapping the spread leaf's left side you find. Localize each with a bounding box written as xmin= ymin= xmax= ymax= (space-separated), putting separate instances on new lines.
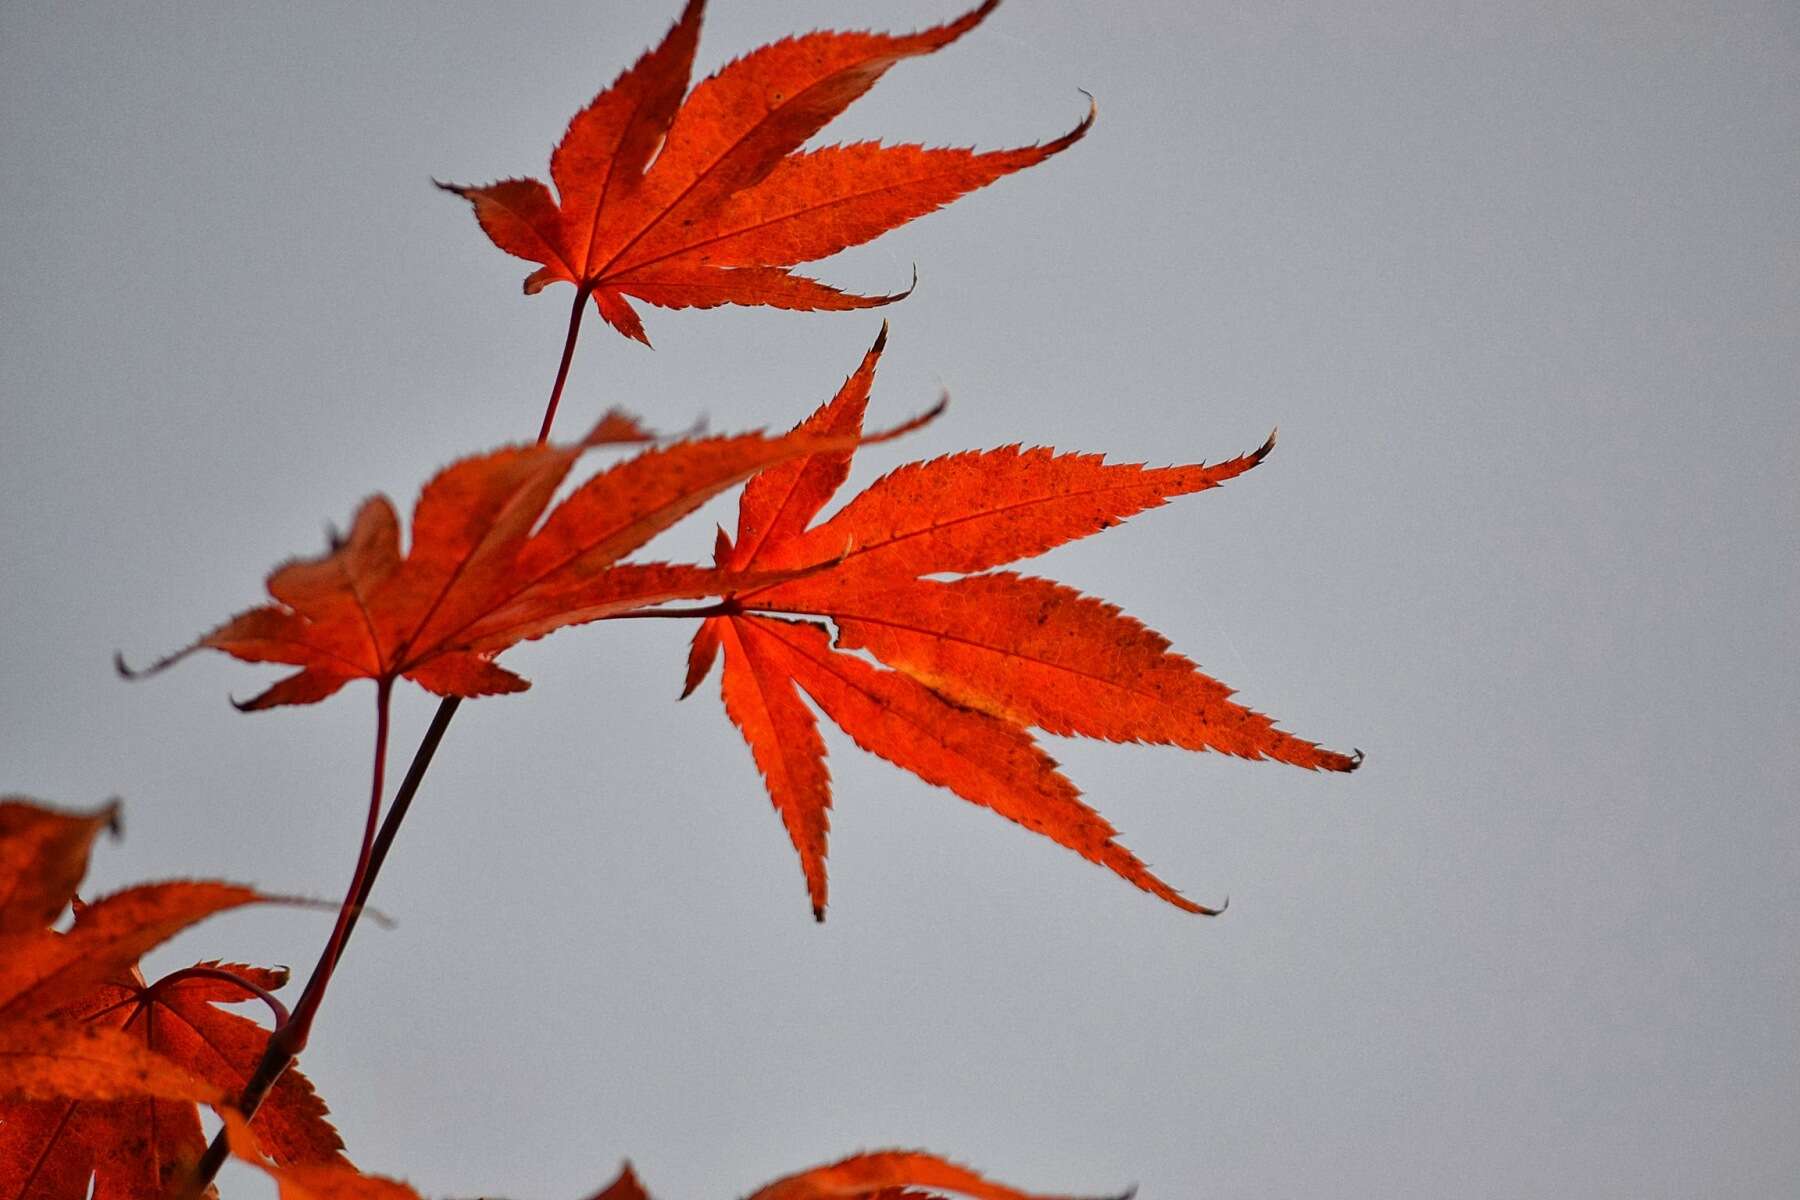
xmin=119 ymin=414 xmax=931 ymax=709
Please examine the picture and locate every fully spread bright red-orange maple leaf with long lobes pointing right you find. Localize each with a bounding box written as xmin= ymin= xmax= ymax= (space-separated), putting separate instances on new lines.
xmin=684 ymin=331 xmax=1359 ymax=919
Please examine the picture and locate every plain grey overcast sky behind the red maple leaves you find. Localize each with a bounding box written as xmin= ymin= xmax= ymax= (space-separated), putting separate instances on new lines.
xmin=0 ymin=0 xmax=1800 ymax=1200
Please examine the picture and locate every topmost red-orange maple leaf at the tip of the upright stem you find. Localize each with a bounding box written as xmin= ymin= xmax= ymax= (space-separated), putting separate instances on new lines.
xmin=439 ymin=0 xmax=1093 ymax=344
